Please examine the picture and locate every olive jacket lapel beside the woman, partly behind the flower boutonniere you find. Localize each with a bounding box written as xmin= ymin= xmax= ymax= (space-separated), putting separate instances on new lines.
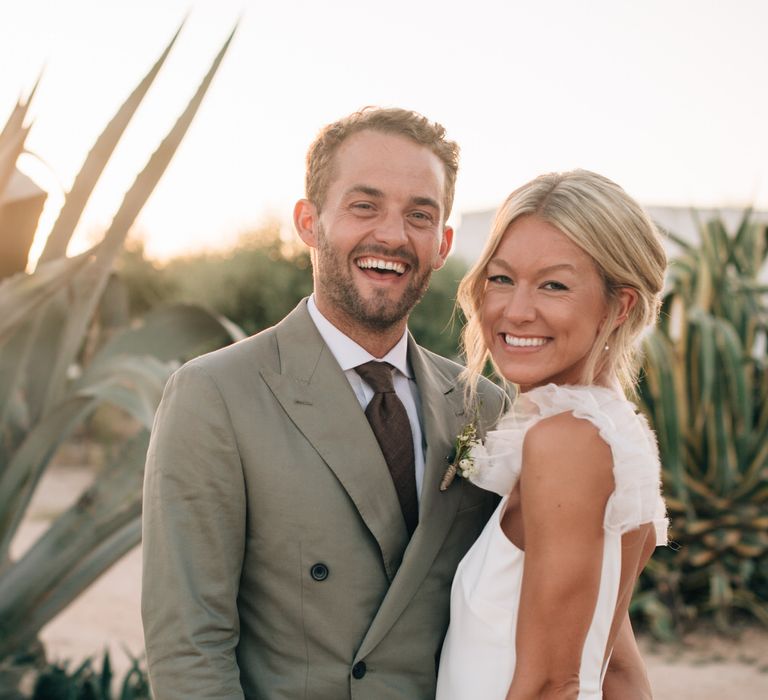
xmin=357 ymin=338 xmax=464 ymax=658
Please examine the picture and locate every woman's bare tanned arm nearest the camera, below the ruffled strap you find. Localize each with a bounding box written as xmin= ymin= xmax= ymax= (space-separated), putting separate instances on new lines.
xmin=507 ymin=413 xmax=614 ymax=700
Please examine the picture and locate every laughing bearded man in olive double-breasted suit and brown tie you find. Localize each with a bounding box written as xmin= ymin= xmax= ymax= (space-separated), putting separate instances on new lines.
xmin=142 ymin=108 xmax=503 ymax=700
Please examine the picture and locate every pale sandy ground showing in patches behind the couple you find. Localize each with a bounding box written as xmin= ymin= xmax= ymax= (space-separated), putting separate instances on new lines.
xmin=13 ymin=467 xmax=768 ymax=700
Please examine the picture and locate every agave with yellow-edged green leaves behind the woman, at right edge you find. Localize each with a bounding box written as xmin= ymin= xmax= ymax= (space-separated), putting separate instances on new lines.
xmin=636 ymin=211 xmax=768 ymax=636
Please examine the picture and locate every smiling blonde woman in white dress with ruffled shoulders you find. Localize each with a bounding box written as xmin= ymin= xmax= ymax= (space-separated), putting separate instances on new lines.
xmin=437 ymin=170 xmax=667 ymax=700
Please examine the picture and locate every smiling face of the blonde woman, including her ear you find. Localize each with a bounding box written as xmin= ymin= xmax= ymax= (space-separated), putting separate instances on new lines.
xmin=480 ymin=215 xmax=637 ymax=391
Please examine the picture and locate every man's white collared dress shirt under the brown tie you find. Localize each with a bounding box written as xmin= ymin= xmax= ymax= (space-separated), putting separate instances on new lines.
xmin=307 ymin=294 xmax=424 ymax=502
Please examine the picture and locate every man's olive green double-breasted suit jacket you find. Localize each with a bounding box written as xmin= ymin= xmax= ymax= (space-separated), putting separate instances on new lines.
xmin=142 ymin=302 xmax=503 ymax=700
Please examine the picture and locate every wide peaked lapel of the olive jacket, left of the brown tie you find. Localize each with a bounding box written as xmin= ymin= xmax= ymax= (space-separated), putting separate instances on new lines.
xmin=261 ymin=302 xmax=408 ymax=581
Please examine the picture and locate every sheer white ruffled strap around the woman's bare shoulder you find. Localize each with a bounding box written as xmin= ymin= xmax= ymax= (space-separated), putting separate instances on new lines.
xmin=470 ymin=384 xmax=668 ymax=545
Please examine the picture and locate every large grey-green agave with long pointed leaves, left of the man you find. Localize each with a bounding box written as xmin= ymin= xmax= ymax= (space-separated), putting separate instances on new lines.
xmin=0 ymin=17 xmax=243 ymax=668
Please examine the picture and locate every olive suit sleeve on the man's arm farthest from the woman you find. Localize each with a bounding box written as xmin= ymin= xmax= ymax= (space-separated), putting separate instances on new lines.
xmin=142 ymin=364 xmax=246 ymax=700
